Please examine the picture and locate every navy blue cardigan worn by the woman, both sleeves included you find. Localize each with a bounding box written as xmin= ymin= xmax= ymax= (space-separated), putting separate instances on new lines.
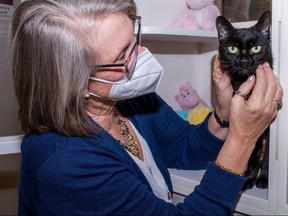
xmin=19 ymin=93 xmax=246 ymax=215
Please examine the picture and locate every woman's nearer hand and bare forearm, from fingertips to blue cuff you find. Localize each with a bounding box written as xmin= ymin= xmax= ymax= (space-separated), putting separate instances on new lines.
xmin=217 ymin=63 xmax=283 ymax=172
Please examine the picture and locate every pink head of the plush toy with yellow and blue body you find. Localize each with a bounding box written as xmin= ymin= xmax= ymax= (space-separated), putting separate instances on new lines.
xmin=174 ymin=82 xmax=207 ymax=110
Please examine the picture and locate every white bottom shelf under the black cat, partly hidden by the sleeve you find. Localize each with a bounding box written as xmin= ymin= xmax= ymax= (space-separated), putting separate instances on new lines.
xmin=169 ymin=169 xmax=269 ymax=215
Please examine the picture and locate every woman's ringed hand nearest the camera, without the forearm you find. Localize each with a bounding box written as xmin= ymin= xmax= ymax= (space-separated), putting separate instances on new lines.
xmin=229 ymin=63 xmax=283 ymax=146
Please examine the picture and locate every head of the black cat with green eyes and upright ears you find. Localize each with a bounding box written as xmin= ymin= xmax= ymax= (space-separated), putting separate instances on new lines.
xmin=216 ymin=11 xmax=272 ymax=89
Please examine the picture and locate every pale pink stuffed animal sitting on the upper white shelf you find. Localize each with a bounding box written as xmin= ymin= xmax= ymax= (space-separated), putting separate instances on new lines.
xmin=170 ymin=0 xmax=220 ymax=30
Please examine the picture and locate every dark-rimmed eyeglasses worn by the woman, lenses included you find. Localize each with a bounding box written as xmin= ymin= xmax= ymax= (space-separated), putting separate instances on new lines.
xmin=94 ymin=16 xmax=141 ymax=79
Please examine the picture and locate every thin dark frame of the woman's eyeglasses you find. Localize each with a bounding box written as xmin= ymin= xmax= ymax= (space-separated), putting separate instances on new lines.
xmin=92 ymin=16 xmax=141 ymax=79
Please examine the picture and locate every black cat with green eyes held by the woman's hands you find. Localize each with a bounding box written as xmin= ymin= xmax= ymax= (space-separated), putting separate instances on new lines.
xmin=216 ymin=11 xmax=273 ymax=189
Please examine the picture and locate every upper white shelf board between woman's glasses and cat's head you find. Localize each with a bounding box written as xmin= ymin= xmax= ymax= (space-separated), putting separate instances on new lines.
xmin=142 ymin=26 xmax=218 ymax=43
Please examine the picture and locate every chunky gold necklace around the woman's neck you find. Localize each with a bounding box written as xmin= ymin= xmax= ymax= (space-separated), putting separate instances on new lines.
xmin=114 ymin=109 xmax=140 ymax=159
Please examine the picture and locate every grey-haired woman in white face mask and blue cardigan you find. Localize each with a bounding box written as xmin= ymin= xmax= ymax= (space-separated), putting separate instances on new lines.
xmin=11 ymin=0 xmax=283 ymax=215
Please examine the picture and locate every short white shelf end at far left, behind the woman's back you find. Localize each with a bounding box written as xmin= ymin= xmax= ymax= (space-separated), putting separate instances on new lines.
xmin=0 ymin=135 xmax=23 ymax=155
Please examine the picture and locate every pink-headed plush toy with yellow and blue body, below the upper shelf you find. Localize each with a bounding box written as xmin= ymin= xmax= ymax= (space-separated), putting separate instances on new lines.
xmin=174 ymin=82 xmax=212 ymax=125
